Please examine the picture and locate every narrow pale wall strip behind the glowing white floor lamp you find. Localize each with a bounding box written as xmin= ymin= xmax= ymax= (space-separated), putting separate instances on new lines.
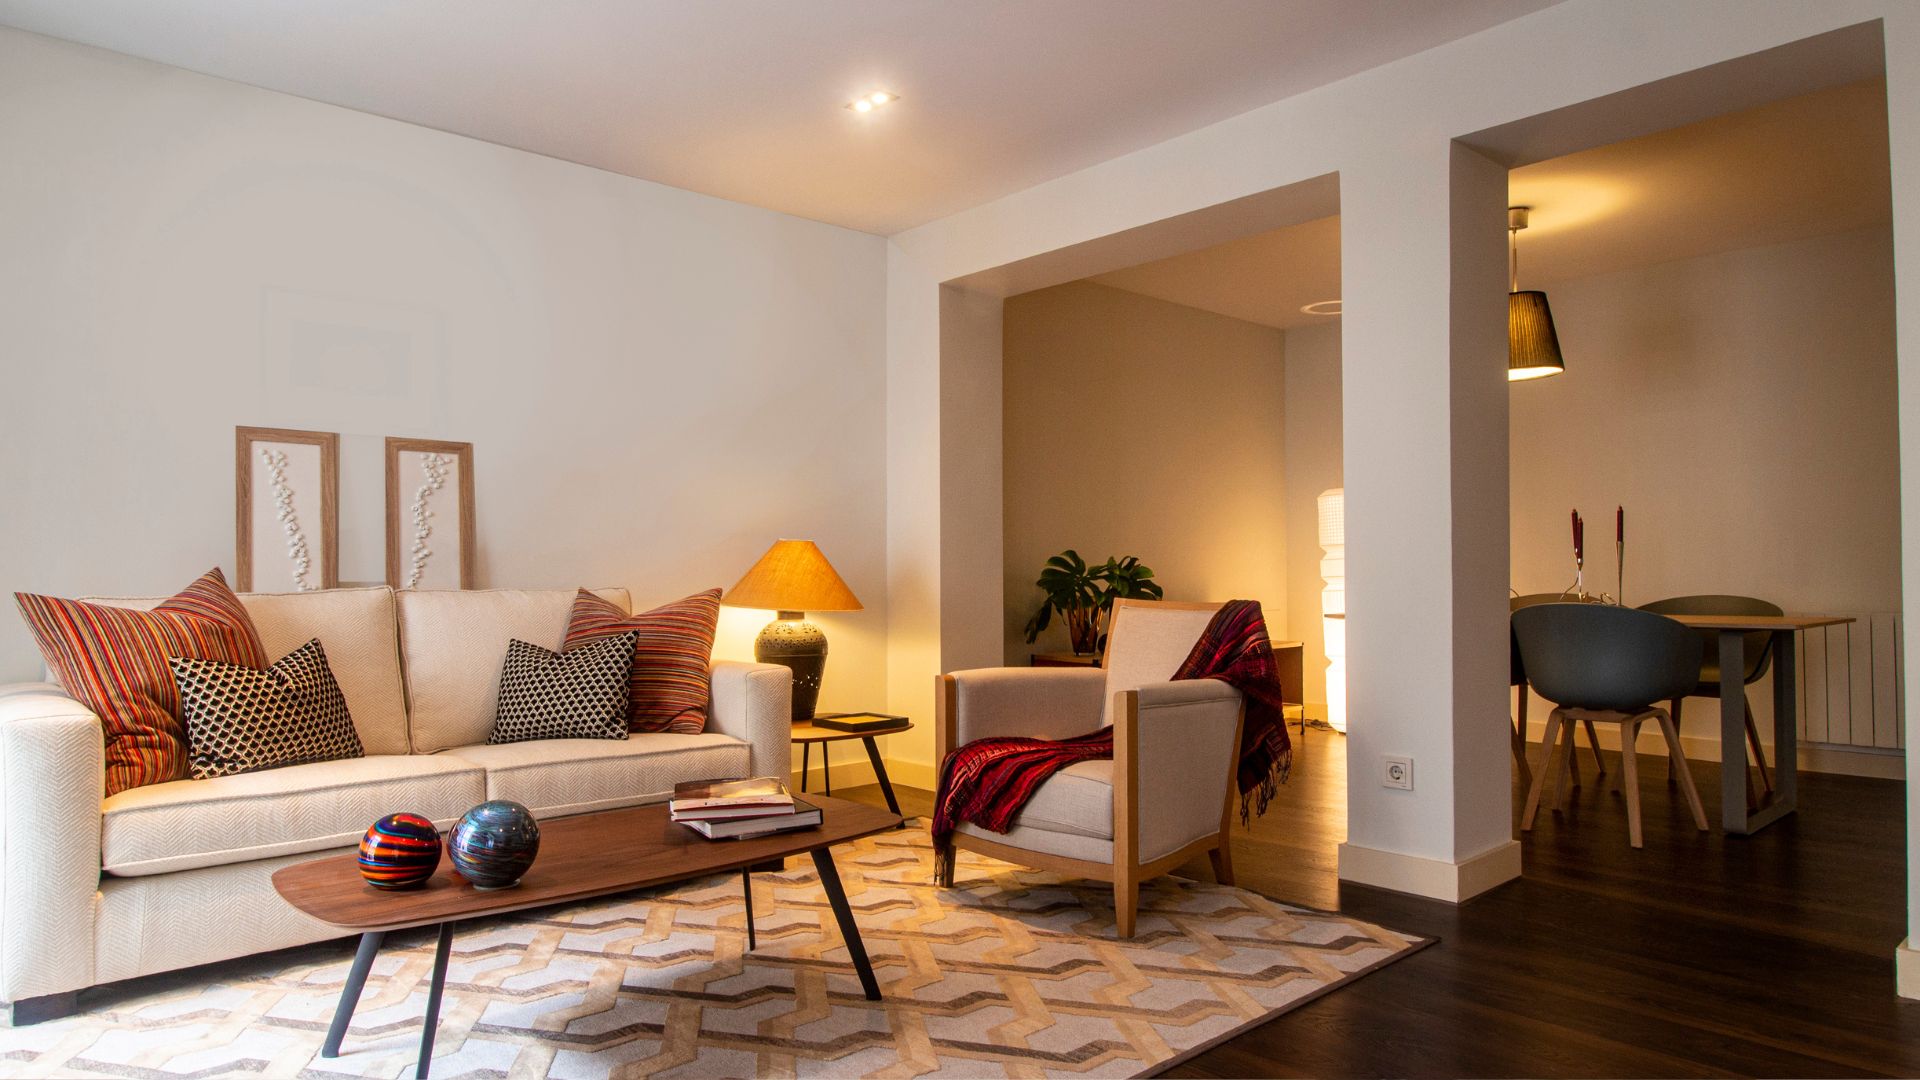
xmin=1286 ymin=319 xmax=1340 ymax=719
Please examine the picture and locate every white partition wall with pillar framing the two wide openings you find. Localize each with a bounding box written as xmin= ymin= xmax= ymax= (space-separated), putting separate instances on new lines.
xmin=887 ymin=0 xmax=1920 ymax=914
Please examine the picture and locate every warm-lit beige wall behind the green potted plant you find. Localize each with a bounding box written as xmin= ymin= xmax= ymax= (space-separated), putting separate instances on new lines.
xmin=1002 ymin=282 xmax=1288 ymax=665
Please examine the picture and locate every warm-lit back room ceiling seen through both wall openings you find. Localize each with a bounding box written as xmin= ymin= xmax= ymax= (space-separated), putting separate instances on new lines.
xmin=1091 ymin=79 xmax=1893 ymax=329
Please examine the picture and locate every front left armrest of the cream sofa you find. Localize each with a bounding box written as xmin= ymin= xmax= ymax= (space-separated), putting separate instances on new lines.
xmin=0 ymin=682 xmax=106 ymax=1001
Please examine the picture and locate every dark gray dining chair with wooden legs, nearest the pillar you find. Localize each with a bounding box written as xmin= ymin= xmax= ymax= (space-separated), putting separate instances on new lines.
xmin=1513 ymin=603 xmax=1707 ymax=847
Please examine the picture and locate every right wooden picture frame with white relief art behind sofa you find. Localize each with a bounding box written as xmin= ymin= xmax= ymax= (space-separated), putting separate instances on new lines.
xmin=386 ymin=436 xmax=474 ymax=588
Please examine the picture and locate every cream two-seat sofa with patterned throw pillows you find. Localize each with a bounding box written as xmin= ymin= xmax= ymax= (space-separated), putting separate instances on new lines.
xmin=0 ymin=586 xmax=791 ymax=1022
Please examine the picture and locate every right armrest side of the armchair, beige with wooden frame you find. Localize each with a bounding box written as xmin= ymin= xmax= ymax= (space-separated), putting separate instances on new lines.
xmin=1114 ymin=678 xmax=1242 ymax=863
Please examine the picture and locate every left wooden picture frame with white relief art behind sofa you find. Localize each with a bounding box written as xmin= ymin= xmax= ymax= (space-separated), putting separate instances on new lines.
xmin=234 ymin=427 xmax=340 ymax=592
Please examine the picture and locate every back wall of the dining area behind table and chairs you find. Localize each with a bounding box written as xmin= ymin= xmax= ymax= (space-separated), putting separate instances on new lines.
xmin=1511 ymin=227 xmax=1901 ymax=744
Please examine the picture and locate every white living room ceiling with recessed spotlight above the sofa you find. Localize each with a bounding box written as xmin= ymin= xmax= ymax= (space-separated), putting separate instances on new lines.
xmin=0 ymin=0 xmax=1553 ymax=234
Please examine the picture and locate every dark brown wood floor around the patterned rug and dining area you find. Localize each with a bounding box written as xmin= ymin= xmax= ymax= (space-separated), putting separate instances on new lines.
xmin=860 ymin=730 xmax=1920 ymax=1076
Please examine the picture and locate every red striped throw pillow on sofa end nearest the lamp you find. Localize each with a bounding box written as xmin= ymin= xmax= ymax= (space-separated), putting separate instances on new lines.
xmin=564 ymin=588 xmax=720 ymax=734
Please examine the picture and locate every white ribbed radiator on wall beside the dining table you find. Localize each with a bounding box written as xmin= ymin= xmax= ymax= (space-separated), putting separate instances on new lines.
xmin=1793 ymin=611 xmax=1907 ymax=749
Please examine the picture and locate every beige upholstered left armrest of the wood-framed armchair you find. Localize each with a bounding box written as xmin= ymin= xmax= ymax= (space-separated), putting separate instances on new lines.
xmin=933 ymin=667 xmax=1106 ymax=765
